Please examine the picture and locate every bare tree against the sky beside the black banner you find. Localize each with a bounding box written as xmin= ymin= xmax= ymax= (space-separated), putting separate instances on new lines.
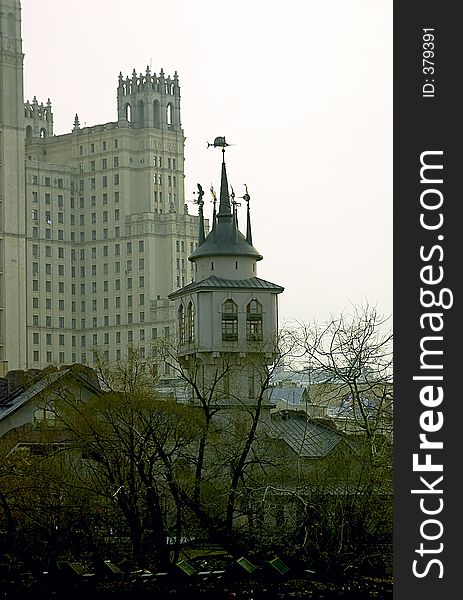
xmin=294 ymin=305 xmax=393 ymax=463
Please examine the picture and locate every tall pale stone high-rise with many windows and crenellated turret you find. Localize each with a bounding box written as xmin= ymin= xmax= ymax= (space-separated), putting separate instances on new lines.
xmin=0 ymin=0 xmax=198 ymax=374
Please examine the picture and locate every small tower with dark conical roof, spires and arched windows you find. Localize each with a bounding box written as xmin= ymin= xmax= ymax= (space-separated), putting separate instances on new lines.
xmin=169 ymin=148 xmax=284 ymax=405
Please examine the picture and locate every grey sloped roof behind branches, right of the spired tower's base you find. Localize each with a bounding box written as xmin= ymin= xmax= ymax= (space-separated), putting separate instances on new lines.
xmin=267 ymin=414 xmax=346 ymax=458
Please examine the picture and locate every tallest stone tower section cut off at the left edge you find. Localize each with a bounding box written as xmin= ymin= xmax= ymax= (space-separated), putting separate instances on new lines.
xmin=0 ymin=0 xmax=26 ymax=374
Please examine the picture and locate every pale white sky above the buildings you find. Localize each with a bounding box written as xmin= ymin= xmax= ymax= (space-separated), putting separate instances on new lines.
xmin=22 ymin=0 xmax=392 ymax=328
